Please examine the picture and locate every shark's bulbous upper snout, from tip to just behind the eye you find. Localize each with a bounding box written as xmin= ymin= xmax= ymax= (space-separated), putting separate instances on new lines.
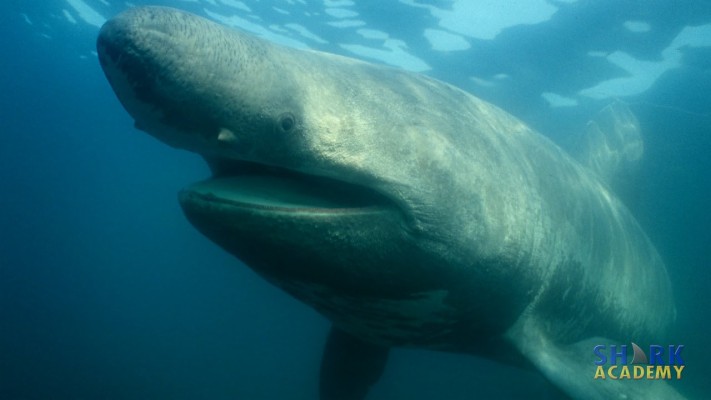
xmin=97 ymin=7 xmax=312 ymax=164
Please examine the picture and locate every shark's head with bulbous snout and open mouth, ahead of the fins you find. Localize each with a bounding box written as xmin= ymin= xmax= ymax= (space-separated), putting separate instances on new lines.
xmin=97 ymin=7 xmax=532 ymax=341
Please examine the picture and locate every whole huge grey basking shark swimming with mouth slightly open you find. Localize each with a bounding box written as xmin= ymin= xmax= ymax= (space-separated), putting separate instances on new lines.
xmin=97 ymin=7 xmax=681 ymax=400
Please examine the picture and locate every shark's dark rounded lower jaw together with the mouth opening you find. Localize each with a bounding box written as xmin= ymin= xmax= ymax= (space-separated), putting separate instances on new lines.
xmin=179 ymin=160 xmax=417 ymax=297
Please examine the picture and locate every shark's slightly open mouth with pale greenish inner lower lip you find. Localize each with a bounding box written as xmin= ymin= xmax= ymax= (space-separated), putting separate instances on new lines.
xmin=180 ymin=161 xmax=392 ymax=213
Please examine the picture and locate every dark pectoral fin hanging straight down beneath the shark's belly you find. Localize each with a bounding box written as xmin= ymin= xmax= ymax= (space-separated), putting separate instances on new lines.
xmin=320 ymin=327 xmax=390 ymax=400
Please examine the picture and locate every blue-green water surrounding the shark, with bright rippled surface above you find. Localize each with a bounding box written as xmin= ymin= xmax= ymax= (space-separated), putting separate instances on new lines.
xmin=0 ymin=0 xmax=711 ymax=400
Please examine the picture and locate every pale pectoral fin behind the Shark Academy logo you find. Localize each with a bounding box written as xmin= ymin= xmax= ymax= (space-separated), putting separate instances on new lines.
xmin=507 ymin=318 xmax=686 ymax=400
